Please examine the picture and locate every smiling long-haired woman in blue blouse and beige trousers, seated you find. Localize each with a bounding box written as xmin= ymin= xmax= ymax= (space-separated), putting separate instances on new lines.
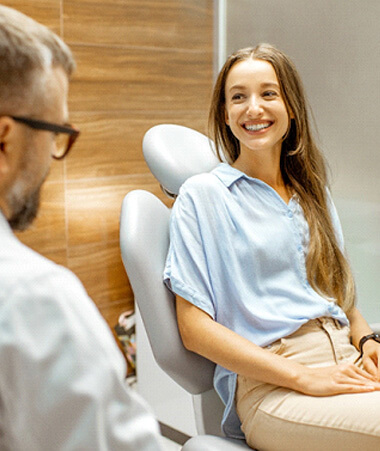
xmin=164 ymin=44 xmax=380 ymax=451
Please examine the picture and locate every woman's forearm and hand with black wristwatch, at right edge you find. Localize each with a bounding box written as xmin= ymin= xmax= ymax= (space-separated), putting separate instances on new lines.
xmin=347 ymin=307 xmax=380 ymax=381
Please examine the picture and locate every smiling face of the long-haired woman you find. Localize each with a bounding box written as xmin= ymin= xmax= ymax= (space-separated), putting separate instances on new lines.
xmin=225 ymin=59 xmax=290 ymax=156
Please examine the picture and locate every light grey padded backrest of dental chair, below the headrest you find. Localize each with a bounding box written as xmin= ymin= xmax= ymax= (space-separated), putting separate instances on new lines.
xmin=120 ymin=190 xmax=214 ymax=394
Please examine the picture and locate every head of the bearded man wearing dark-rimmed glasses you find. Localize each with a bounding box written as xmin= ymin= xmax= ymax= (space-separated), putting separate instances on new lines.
xmin=0 ymin=6 xmax=75 ymax=233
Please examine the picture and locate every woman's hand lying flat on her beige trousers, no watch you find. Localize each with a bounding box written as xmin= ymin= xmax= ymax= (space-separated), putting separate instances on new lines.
xmin=297 ymin=362 xmax=380 ymax=396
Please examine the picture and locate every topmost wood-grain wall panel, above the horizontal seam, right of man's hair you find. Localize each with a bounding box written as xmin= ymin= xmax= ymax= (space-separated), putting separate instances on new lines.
xmin=64 ymin=0 xmax=213 ymax=52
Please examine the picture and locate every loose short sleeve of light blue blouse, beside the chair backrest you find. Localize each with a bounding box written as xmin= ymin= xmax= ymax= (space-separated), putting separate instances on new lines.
xmin=164 ymin=187 xmax=215 ymax=319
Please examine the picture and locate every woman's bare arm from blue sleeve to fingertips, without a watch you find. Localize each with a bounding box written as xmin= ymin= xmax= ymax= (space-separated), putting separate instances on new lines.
xmin=176 ymin=296 xmax=380 ymax=396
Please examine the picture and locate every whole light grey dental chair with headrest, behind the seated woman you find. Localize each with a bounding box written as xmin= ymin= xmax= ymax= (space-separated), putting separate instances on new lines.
xmin=120 ymin=124 xmax=250 ymax=451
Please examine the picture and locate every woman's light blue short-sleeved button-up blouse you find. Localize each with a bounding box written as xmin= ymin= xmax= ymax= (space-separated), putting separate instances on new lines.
xmin=164 ymin=163 xmax=348 ymax=438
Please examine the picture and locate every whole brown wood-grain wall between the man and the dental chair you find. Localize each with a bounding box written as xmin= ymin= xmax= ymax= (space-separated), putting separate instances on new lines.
xmin=8 ymin=0 xmax=213 ymax=327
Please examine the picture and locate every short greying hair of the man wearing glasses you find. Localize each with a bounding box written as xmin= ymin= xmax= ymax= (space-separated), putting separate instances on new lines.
xmin=0 ymin=5 xmax=75 ymax=114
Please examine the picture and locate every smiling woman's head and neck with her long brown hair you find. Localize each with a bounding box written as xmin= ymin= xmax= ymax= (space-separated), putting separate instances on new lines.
xmin=209 ymin=44 xmax=355 ymax=314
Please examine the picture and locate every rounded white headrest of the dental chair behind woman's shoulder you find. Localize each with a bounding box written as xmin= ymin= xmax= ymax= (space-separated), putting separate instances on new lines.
xmin=143 ymin=124 xmax=220 ymax=195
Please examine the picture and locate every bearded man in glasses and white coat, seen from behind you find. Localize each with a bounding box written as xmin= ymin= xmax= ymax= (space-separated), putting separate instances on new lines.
xmin=0 ymin=6 xmax=161 ymax=451
